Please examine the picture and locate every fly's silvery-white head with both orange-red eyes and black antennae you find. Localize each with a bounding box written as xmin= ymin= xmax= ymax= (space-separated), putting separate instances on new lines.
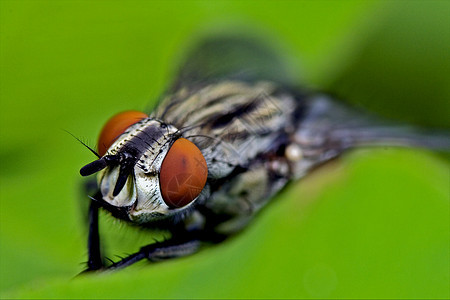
xmin=81 ymin=112 xmax=208 ymax=224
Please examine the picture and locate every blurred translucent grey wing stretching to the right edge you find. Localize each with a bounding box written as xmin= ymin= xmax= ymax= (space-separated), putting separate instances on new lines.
xmin=297 ymin=95 xmax=450 ymax=150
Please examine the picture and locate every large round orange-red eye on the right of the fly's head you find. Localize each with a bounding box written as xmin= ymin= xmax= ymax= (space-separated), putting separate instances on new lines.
xmin=159 ymin=138 xmax=208 ymax=208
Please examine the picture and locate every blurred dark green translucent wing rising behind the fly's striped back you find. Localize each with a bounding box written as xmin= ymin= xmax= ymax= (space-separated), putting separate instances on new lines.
xmin=167 ymin=35 xmax=294 ymax=91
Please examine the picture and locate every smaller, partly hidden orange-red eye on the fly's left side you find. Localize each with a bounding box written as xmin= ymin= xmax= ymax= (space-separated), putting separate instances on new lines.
xmin=97 ymin=110 xmax=148 ymax=156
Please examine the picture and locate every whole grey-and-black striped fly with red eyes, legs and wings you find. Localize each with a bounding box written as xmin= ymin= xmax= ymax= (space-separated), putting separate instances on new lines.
xmin=80 ymin=38 xmax=450 ymax=271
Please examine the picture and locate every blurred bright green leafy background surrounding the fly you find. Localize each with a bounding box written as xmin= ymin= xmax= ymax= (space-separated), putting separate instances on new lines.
xmin=0 ymin=0 xmax=450 ymax=298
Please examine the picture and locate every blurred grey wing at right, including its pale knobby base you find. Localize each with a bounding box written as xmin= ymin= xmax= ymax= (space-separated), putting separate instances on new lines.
xmin=293 ymin=95 xmax=450 ymax=178
